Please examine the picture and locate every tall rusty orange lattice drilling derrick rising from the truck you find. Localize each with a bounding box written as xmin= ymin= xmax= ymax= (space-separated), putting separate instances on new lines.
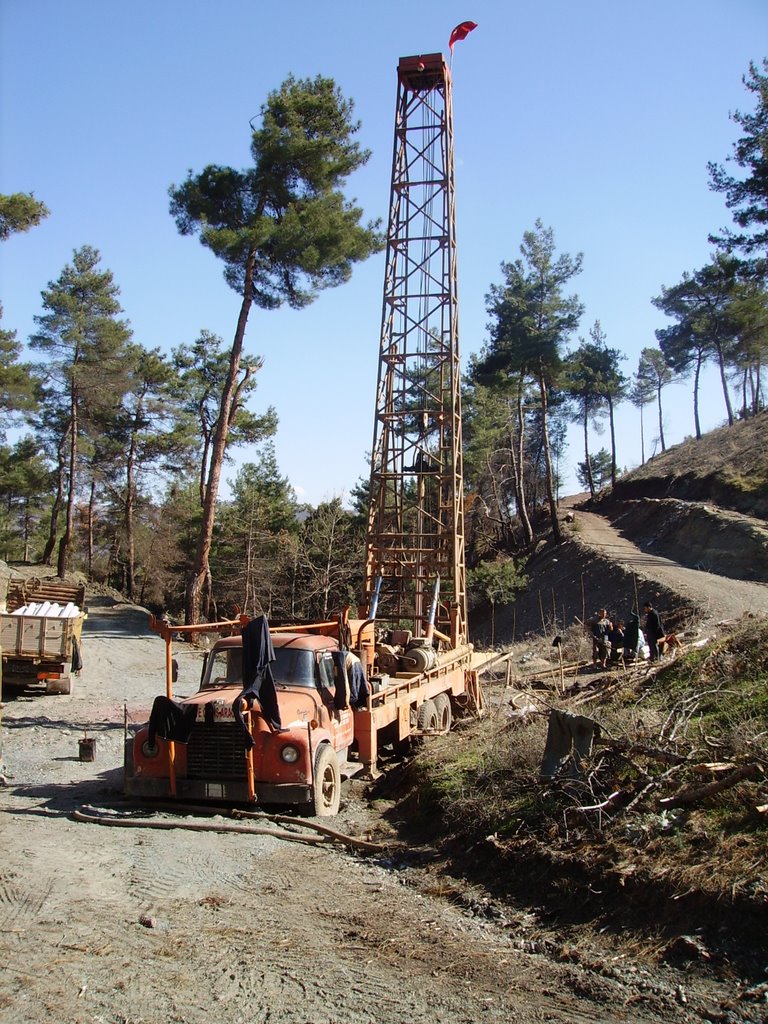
xmin=367 ymin=53 xmax=467 ymax=647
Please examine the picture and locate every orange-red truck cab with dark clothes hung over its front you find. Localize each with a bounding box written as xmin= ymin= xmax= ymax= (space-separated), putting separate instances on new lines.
xmin=125 ymin=632 xmax=354 ymax=815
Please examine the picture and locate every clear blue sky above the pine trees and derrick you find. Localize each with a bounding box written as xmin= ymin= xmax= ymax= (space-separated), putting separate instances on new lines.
xmin=0 ymin=0 xmax=768 ymax=503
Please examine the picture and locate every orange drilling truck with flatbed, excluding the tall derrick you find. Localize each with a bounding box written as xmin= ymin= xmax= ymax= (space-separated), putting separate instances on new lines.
xmin=125 ymin=620 xmax=480 ymax=816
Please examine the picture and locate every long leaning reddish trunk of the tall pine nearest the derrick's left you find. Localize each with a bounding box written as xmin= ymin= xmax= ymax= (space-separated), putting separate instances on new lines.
xmin=185 ymin=249 xmax=256 ymax=625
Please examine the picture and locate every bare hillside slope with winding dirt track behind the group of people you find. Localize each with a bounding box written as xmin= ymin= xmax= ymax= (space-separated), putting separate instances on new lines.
xmin=472 ymin=413 xmax=768 ymax=645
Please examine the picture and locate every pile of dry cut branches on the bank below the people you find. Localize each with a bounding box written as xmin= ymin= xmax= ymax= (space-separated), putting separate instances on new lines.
xmin=506 ymin=638 xmax=768 ymax=838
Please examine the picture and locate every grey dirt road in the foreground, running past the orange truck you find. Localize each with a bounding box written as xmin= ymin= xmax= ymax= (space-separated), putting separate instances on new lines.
xmin=0 ymin=599 xmax=758 ymax=1024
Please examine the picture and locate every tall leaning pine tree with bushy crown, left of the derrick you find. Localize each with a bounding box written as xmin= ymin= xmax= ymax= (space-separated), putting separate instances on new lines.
xmin=170 ymin=77 xmax=381 ymax=622
